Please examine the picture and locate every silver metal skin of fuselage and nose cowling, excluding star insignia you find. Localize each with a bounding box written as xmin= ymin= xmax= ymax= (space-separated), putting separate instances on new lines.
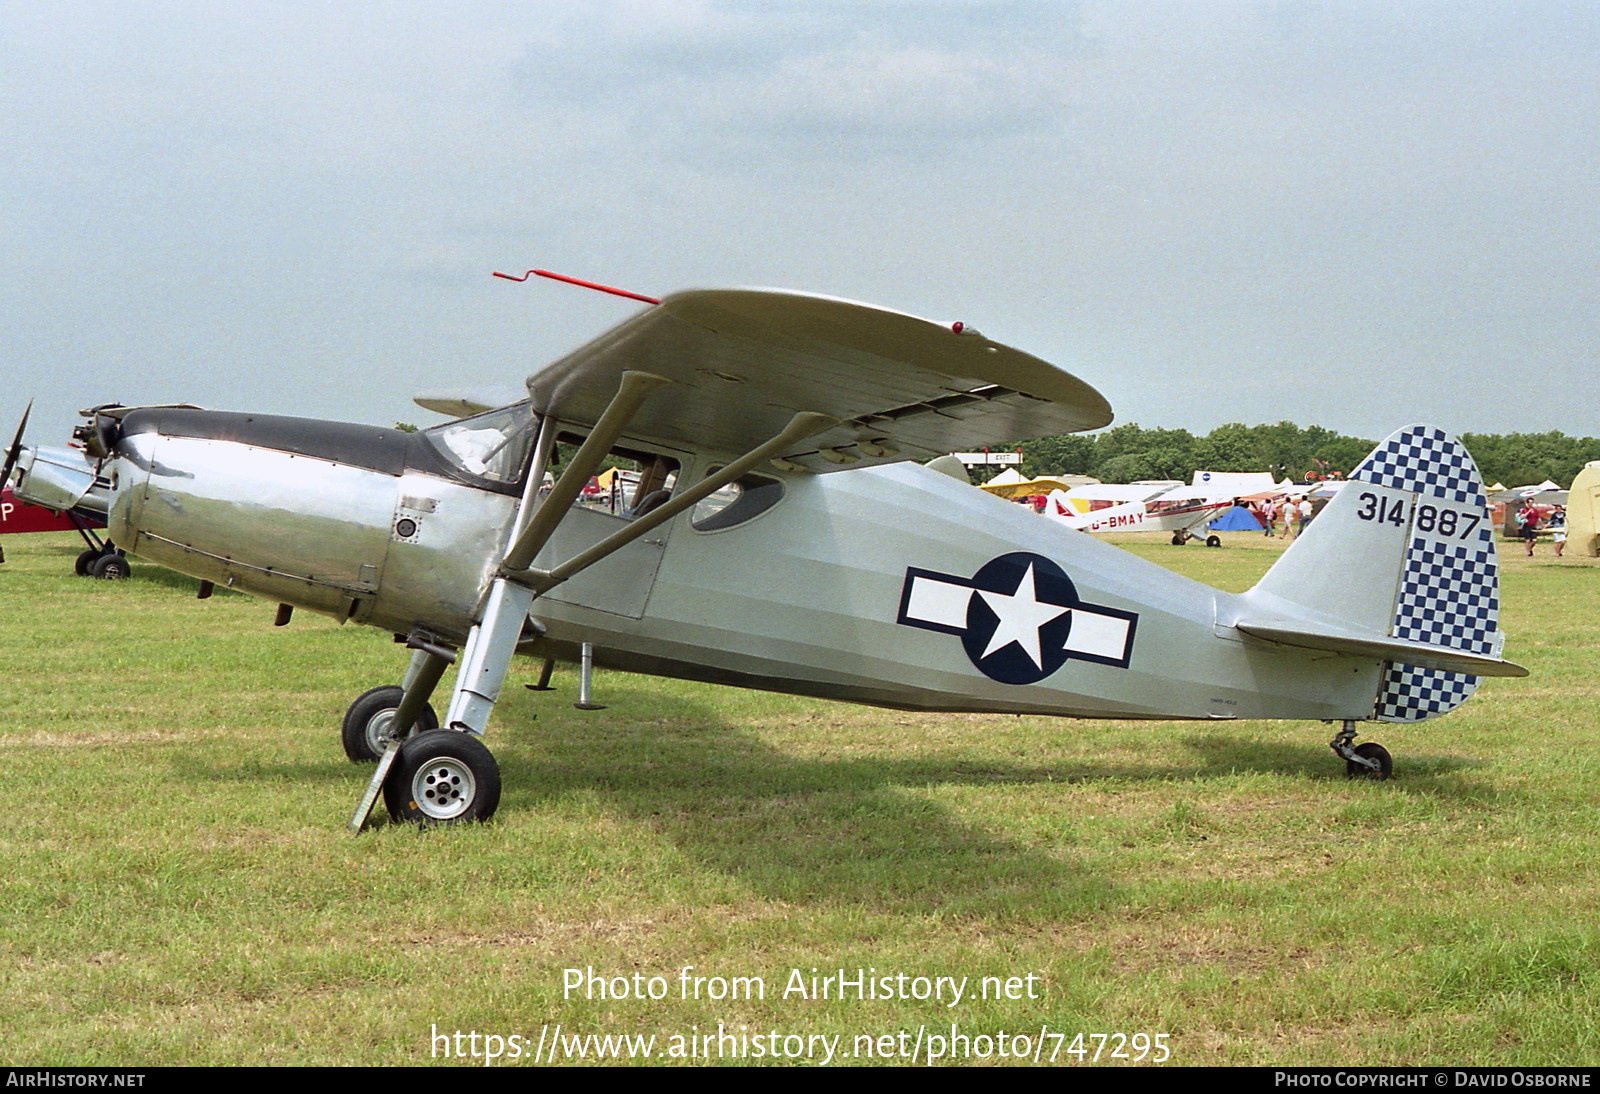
xmin=109 ymin=412 xmax=1381 ymax=720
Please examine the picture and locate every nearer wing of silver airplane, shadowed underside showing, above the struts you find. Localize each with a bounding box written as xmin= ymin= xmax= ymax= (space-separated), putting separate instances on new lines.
xmin=528 ymin=289 xmax=1112 ymax=472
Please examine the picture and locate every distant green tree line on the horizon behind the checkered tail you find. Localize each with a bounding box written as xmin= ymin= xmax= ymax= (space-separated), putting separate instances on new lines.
xmin=992 ymin=422 xmax=1600 ymax=486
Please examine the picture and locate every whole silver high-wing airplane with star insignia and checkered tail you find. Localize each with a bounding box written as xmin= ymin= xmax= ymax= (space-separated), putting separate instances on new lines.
xmin=15 ymin=289 xmax=1525 ymax=828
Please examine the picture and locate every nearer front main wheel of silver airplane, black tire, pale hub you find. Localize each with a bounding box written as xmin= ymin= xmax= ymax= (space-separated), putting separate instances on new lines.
xmin=384 ymin=729 xmax=501 ymax=825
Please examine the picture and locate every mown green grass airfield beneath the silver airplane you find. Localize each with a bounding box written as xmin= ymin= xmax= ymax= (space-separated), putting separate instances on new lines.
xmin=0 ymin=533 xmax=1600 ymax=1067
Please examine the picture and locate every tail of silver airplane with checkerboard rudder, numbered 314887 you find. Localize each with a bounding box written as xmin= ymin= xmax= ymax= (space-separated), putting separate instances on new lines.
xmin=1238 ymin=425 xmax=1525 ymax=721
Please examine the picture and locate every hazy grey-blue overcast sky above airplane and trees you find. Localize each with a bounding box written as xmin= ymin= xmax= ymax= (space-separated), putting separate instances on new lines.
xmin=0 ymin=0 xmax=1600 ymax=443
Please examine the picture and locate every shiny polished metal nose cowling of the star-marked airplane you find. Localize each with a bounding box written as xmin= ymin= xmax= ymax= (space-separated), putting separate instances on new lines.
xmin=109 ymin=432 xmax=515 ymax=626
